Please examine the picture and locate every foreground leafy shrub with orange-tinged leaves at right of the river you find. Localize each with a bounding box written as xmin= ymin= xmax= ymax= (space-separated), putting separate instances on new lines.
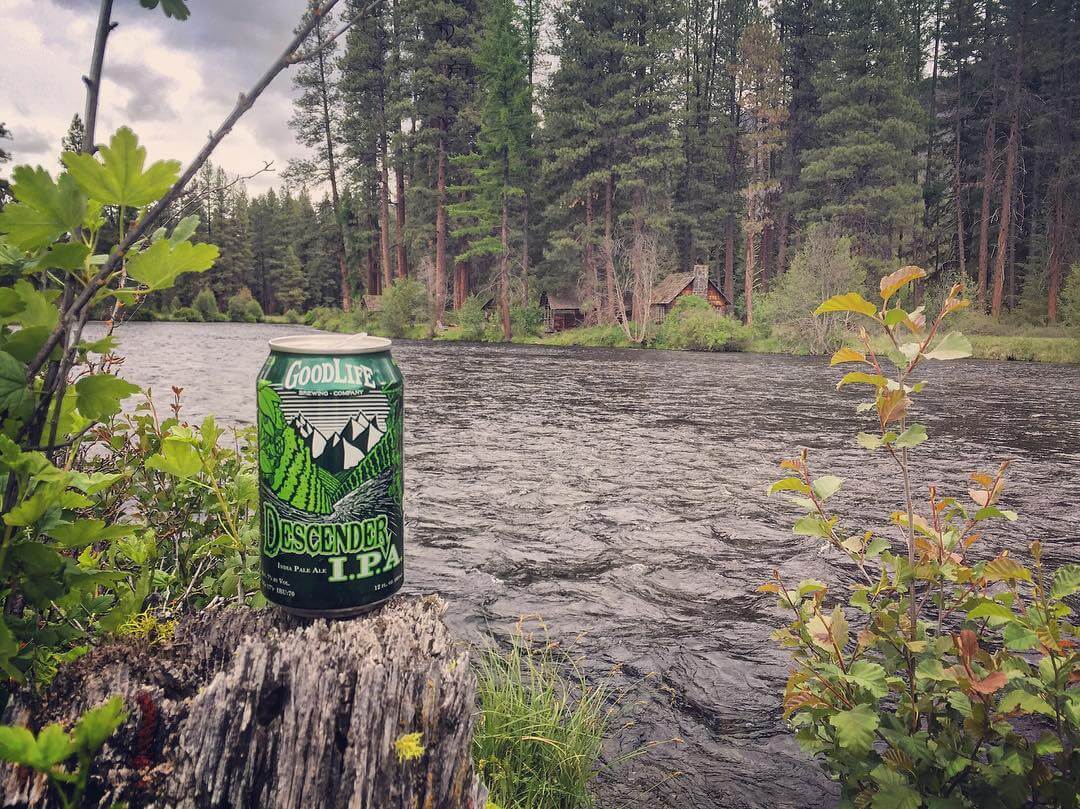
xmin=760 ymin=267 xmax=1080 ymax=809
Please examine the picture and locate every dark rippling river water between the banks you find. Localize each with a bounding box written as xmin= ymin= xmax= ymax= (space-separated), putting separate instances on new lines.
xmin=86 ymin=323 xmax=1080 ymax=808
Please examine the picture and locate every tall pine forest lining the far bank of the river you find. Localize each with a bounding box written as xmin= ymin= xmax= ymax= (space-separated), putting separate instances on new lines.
xmin=27 ymin=0 xmax=1080 ymax=337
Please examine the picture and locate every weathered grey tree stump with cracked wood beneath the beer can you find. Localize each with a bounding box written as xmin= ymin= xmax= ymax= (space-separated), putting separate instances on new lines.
xmin=0 ymin=597 xmax=486 ymax=809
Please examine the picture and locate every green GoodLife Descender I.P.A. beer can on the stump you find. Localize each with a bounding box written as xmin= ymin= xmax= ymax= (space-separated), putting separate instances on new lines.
xmin=257 ymin=334 xmax=405 ymax=617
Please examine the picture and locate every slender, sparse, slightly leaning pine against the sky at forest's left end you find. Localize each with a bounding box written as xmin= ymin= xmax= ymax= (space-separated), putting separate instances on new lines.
xmin=288 ymin=10 xmax=352 ymax=311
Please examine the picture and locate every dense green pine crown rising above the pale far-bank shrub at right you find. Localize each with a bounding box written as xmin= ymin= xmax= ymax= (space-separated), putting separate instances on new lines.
xmin=800 ymin=0 xmax=922 ymax=271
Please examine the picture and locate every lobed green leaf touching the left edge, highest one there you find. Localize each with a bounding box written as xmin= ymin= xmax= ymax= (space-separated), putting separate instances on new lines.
xmin=0 ymin=165 xmax=86 ymax=252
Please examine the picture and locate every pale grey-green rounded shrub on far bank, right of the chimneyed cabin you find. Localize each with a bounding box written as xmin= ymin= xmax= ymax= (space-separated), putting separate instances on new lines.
xmin=755 ymin=225 xmax=865 ymax=354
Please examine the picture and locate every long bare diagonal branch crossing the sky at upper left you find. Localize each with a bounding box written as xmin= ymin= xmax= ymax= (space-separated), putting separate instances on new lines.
xmin=26 ymin=0 xmax=338 ymax=381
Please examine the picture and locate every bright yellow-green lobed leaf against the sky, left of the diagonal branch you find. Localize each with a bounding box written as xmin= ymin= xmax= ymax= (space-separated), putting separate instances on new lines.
xmin=60 ymin=126 xmax=180 ymax=207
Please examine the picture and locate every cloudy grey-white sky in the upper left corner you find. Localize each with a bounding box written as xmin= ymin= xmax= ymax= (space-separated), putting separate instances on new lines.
xmin=0 ymin=0 xmax=315 ymax=191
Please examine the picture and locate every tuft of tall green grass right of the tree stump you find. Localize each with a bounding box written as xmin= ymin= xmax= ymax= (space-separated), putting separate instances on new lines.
xmin=473 ymin=634 xmax=608 ymax=809
